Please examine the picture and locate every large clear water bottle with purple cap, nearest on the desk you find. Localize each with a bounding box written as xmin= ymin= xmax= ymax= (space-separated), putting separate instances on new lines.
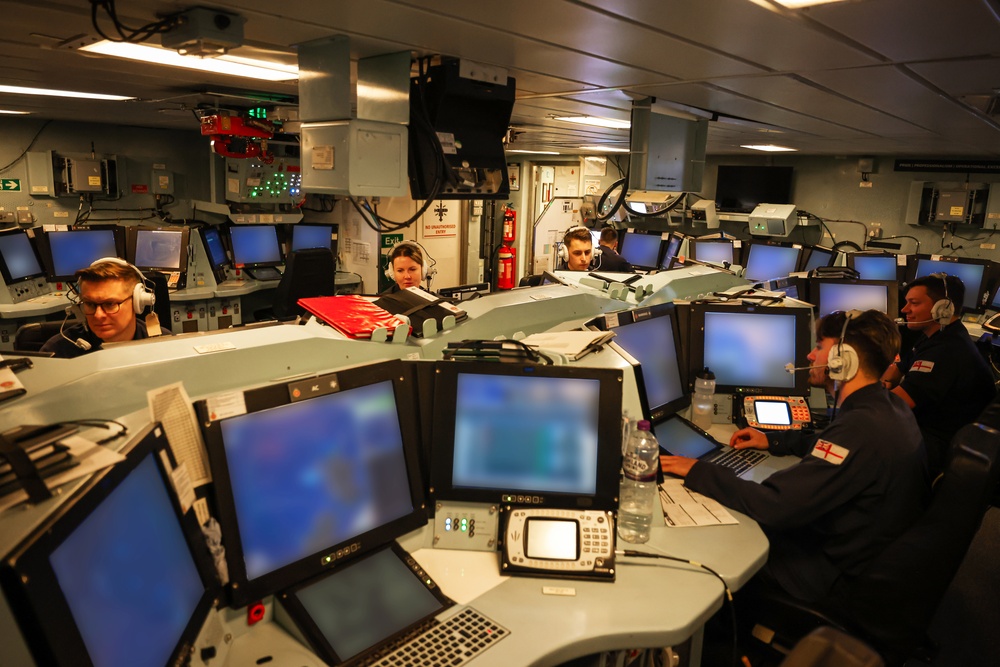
xmin=618 ymin=419 xmax=660 ymax=544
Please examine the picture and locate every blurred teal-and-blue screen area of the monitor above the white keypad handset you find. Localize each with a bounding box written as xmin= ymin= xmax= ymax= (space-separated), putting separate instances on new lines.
xmin=452 ymin=373 xmax=601 ymax=495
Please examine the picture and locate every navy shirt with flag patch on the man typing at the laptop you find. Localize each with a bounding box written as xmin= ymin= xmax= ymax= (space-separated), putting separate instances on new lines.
xmin=685 ymin=382 xmax=930 ymax=602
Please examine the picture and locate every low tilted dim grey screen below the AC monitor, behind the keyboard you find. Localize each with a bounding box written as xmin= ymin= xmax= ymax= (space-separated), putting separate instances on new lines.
xmin=295 ymin=549 xmax=443 ymax=661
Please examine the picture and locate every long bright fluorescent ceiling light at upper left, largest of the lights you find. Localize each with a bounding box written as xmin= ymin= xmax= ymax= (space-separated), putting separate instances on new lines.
xmin=80 ymin=40 xmax=299 ymax=81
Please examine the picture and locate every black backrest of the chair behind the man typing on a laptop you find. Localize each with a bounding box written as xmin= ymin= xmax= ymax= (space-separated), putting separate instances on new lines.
xmin=835 ymin=420 xmax=1000 ymax=654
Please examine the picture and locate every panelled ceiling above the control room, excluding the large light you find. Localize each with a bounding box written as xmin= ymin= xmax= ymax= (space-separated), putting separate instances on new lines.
xmin=0 ymin=0 xmax=1000 ymax=159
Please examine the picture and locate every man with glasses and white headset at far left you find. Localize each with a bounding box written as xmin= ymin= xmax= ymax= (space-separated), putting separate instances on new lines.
xmin=41 ymin=258 xmax=152 ymax=358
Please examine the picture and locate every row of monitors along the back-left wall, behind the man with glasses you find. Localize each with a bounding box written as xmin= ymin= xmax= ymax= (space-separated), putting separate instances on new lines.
xmin=0 ymin=223 xmax=333 ymax=285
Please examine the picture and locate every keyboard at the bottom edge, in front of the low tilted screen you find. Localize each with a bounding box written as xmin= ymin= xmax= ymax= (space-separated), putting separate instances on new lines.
xmin=364 ymin=608 xmax=510 ymax=667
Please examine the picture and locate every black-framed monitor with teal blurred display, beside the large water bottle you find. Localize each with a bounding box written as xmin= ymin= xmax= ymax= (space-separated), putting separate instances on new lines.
xmin=431 ymin=362 xmax=622 ymax=510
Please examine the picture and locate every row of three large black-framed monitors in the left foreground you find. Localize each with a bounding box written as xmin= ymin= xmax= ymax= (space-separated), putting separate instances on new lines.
xmin=0 ymin=360 xmax=622 ymax=666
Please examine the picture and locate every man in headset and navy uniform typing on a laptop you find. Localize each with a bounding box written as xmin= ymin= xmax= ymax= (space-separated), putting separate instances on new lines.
xmin=660 ymin=310 xmax=930 ymax=602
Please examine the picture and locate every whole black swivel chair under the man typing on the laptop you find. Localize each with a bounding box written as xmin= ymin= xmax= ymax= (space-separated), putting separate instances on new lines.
xmin=750 ymin=414 xmax=1000 ymax=666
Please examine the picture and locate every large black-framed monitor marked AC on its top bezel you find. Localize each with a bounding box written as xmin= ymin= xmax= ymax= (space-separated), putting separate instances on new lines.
xmin=196 ymin=361 xmax=427 ymax=606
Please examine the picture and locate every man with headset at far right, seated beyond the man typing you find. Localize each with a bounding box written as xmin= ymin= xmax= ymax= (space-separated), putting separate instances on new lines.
xmin=882 ymin=273 xmax=996 ymax=475
